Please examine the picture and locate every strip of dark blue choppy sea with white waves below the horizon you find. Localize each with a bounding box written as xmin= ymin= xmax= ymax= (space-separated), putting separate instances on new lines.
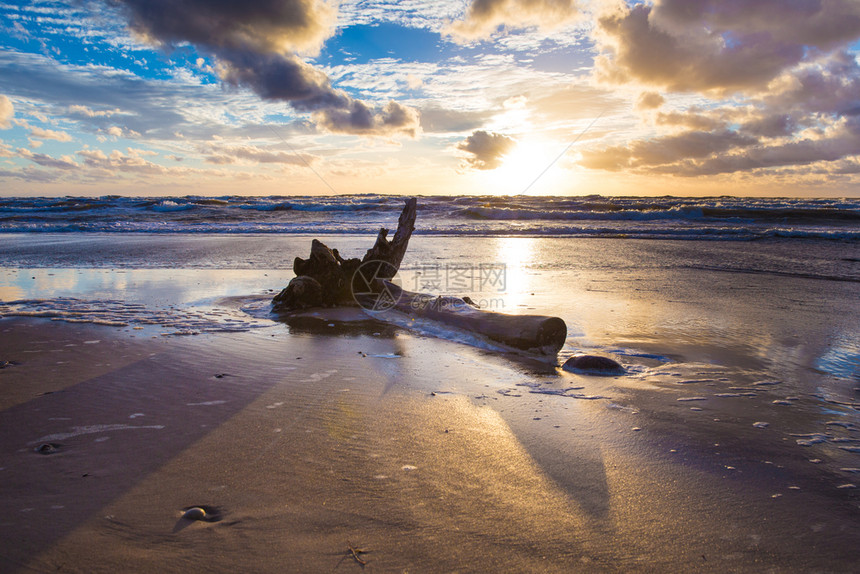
xmin=0 ymin=195 xmax=860 ymax=241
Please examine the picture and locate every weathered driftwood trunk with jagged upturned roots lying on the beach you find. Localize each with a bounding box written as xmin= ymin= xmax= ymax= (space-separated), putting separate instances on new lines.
xmin=272 ymin=198 xmax=567 ymax=356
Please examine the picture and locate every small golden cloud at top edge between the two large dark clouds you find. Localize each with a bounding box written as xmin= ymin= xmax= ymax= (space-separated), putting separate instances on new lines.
xmin=445 ymin=0 xmax=580 ymax=41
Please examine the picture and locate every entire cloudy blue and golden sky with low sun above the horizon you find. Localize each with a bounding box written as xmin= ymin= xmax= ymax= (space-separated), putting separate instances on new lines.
xmin=0 ymin=0 xmax=860 ymax=197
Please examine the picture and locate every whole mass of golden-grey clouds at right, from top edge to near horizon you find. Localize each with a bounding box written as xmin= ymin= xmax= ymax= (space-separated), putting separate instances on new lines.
xmin=582 ymin=0 xmax=860 ymax=180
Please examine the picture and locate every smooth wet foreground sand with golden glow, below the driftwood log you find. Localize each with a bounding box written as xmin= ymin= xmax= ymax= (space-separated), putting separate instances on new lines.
xmin=0 ymin=319 xmax=860 ymax=572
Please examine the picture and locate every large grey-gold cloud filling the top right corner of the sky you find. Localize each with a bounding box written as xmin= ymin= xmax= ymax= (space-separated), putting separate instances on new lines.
xmin=595 ymin=0 xmax=860 ymax=92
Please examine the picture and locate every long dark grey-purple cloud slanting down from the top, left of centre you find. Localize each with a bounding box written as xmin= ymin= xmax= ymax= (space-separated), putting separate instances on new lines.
xmin=106 ymin=0 xmax=419 ymax=137
